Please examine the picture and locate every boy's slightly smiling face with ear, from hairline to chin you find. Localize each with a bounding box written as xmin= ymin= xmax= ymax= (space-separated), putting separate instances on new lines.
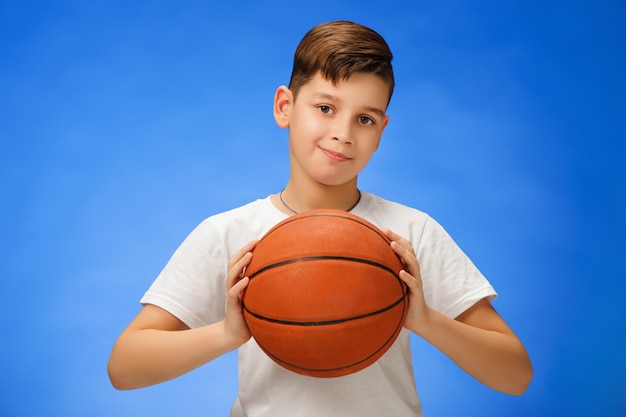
xmin=274 ymin=73 xmax=389 ymax=185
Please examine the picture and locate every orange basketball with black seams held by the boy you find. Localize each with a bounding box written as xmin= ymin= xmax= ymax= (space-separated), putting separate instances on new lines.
xmin=243 ymin=210 xmax=409 ymax=377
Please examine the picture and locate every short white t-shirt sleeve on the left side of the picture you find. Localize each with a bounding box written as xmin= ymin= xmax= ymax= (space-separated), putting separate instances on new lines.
xmin=141 ymin=220 xmax=228 ymax=328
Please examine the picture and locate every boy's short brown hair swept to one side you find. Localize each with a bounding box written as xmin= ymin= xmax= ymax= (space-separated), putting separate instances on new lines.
xmin=289 ymin=20 xmax=394 ymax=103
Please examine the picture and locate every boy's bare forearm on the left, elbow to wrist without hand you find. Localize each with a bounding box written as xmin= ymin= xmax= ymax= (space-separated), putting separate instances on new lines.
xmin=108 ymin=322 xmax=238 ymax=389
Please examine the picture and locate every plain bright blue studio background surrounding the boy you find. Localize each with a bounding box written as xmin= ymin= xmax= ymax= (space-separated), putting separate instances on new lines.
xmin=0 ymin=0 xmax=626 ymax=417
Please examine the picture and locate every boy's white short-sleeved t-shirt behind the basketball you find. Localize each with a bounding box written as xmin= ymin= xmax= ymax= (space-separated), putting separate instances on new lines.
xmin=141 ymin=192 xmax=496 ymax=417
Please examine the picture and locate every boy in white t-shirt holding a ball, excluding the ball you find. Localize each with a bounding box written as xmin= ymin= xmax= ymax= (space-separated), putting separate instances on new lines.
xmin=109 ymin=21 xmax=532 ymax=417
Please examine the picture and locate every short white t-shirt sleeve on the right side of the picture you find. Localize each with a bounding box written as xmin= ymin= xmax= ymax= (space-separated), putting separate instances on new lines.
xmin=416 ymin=217 xmax=497 ymax=318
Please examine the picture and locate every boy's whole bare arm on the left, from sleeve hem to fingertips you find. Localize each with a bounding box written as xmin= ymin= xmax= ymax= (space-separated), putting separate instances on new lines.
xmin=108 ymin=242 xmax=255 ymax=389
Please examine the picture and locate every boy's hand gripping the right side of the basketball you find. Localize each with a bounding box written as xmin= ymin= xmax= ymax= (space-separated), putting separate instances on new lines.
xmin=384 ymin=229 xmax=430 ymax=333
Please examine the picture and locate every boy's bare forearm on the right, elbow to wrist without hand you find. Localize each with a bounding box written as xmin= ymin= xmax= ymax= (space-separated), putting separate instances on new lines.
xmin=411 ymin=309 xmax=532 ymax=395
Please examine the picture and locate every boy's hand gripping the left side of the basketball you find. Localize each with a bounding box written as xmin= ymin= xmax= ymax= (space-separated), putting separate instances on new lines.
xmin=224 ymin=240 xmax=257 ymax=346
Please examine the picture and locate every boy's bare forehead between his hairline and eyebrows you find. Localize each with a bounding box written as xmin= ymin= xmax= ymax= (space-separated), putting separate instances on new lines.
xmin=298 ymin=72 xmax=389 ymax=114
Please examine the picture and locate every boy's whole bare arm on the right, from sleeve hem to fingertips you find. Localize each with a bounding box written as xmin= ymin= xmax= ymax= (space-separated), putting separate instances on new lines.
xmin=387 ymin=231 xmax=533 ymax=395
